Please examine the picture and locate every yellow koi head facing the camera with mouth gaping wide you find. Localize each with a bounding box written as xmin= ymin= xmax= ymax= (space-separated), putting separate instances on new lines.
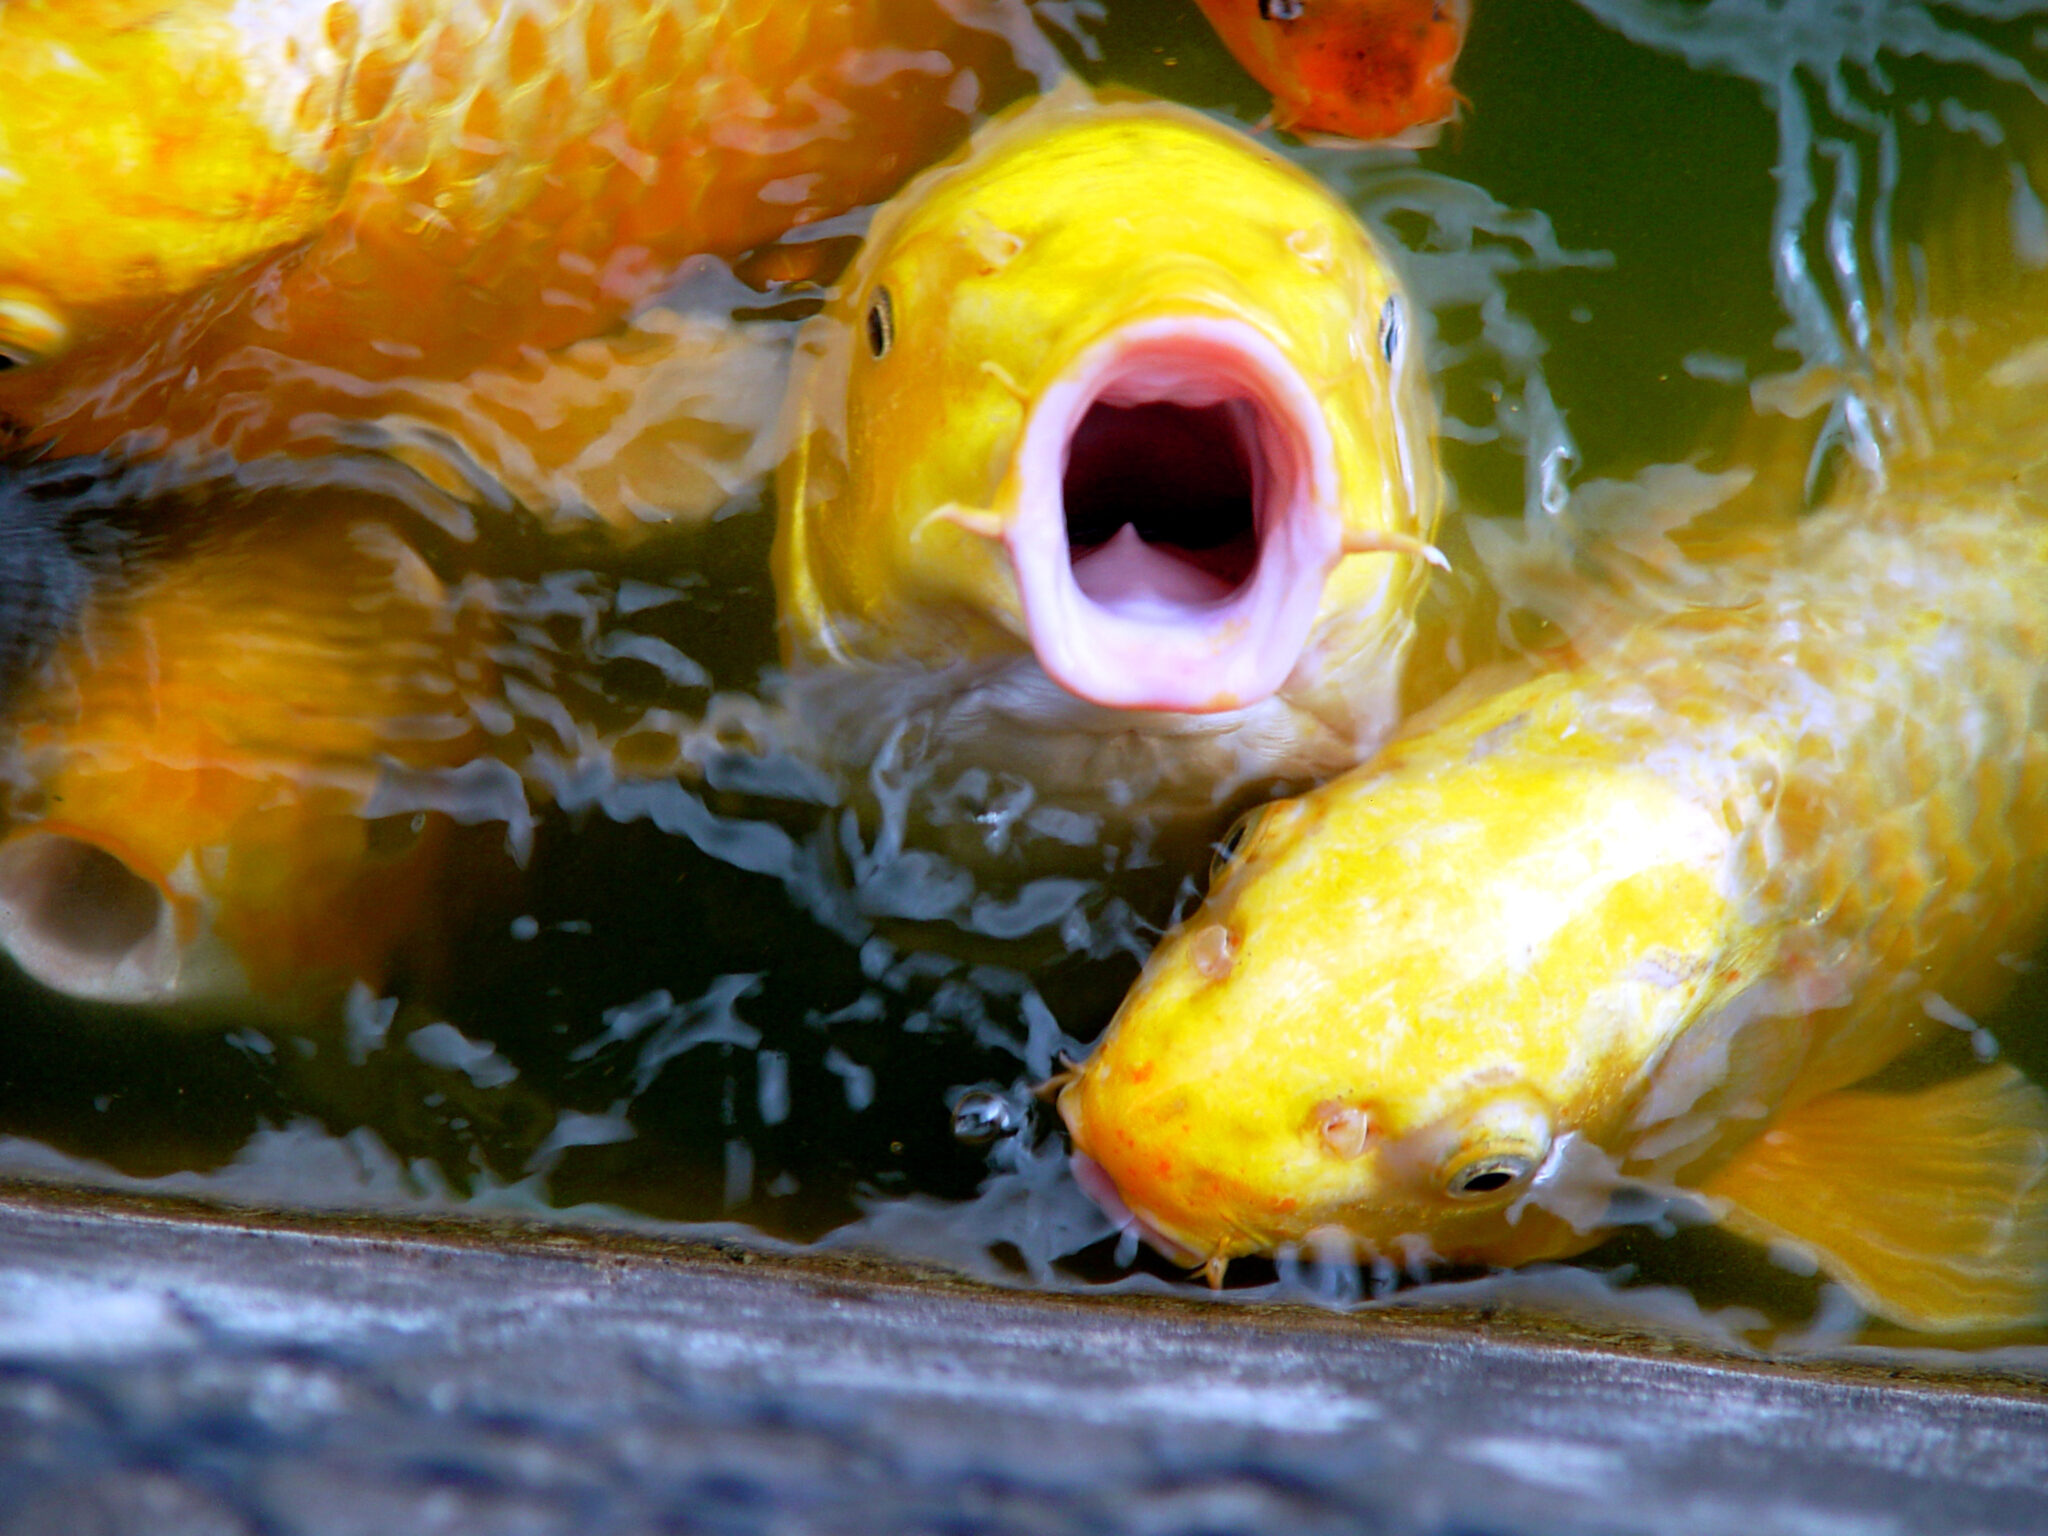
xmin=776 ymin=92 xmax=1440 ymax=713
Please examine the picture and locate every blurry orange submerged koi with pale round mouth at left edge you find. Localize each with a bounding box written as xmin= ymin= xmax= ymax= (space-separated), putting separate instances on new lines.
xmin=0 ymin=514 xmax=489 ymax=1004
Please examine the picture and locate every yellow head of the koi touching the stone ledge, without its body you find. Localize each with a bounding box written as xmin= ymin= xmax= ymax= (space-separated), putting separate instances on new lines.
xmin=1059 ymin=733 xmax=1741 ymax=1264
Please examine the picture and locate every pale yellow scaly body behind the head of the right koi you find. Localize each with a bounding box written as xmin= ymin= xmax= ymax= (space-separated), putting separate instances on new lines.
xmin=1490 ymin=492 xmax=2048 ymax=1094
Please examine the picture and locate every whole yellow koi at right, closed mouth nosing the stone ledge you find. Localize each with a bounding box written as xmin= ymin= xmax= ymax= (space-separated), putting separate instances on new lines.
xmin=1059 ymin=252 xmax=2048 ymax=1329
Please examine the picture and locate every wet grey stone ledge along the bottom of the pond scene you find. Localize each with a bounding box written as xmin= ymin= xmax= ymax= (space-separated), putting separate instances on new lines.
xmin=0 ymin=1190 xmax=2048 ymax=1536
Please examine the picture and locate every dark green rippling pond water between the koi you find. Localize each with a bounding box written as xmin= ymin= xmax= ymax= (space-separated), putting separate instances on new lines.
xmin=0 ymin=0 xmax=2048 ymax=1346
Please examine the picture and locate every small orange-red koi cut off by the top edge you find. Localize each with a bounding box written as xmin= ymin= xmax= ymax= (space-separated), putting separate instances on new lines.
xmin=1196 ymin=0 xmax=1470 ymax=141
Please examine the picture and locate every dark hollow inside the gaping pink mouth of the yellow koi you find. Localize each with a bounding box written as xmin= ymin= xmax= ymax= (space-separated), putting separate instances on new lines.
xmin=1061 ymin=399 xmax=1260 ymax=596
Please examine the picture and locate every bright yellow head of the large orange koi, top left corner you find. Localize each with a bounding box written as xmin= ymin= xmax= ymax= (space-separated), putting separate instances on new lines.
xmin=0 ymin=0 xmax=340 ymax=369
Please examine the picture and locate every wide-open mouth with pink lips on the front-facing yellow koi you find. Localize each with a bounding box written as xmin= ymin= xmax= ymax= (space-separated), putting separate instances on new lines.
xmin=1004 ymin=317 xmax=1343 ymax=713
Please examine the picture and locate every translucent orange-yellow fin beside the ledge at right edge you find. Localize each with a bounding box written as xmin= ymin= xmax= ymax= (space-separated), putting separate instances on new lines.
xmin=1706 ymin=1067 xmax=2048 ymax=1331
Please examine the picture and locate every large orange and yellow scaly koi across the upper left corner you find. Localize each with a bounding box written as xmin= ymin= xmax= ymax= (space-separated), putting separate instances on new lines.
xmin=0 ymin=0 xmax=1051 ymax=481
